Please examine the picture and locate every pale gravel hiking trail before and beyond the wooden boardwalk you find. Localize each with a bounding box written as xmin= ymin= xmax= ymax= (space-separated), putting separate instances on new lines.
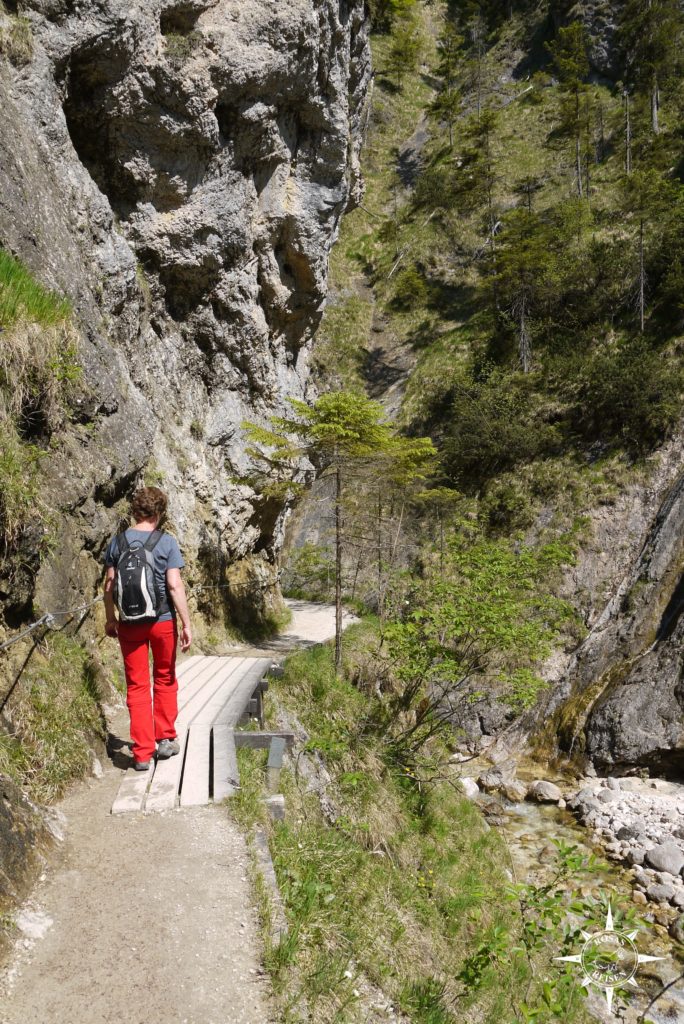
xmin=0 ymin=601 xmax=349 ymax=1024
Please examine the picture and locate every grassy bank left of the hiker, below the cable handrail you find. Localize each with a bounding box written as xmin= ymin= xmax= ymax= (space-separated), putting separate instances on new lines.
xmin=0 ymin=634 xmax=105 ymax=803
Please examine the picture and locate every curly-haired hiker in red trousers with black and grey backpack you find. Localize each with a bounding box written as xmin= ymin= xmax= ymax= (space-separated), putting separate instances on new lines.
xmin=104 ymin=487 xmax=193 ymax=771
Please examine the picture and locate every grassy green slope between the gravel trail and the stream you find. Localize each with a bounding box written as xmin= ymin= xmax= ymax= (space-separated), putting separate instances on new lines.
xmin=230 ymin=621 xmax=586 ymax=1024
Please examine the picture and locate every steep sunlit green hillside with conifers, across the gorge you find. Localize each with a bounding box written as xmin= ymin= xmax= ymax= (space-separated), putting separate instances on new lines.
xmin=292 ymin=0 xmax=684 ymax=767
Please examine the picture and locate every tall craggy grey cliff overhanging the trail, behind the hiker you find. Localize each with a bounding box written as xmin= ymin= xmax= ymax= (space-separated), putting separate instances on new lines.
xmin=0 ymin=0 xmax=370 ymax=622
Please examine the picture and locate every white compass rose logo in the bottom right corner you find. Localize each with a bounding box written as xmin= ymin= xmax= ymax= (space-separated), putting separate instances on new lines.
xmin=554 ymin=904 xmax=665 ymax=1010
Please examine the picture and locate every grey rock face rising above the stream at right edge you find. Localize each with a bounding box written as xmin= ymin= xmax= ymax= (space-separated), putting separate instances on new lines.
xmin=525 ymin=434 xmax=684 ymax=777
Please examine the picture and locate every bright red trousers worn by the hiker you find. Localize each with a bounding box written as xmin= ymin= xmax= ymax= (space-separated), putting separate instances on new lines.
xmin=119 ymin=620 xmax=178 ymax=761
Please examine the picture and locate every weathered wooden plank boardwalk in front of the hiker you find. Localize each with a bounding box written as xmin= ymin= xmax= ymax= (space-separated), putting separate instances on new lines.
xmin=112 ymin=655 xmax=272 ymax=814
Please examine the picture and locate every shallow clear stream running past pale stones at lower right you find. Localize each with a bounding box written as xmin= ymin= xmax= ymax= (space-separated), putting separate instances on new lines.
xmin=464 ymin=762 xmax=684 ymax=1024
